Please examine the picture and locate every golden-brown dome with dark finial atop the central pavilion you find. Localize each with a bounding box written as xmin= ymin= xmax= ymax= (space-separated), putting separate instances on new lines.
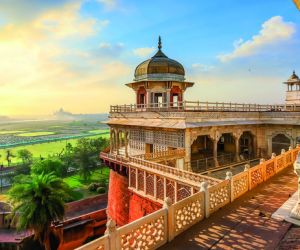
xmin=134 ymin=37 xmax=185 ymax=81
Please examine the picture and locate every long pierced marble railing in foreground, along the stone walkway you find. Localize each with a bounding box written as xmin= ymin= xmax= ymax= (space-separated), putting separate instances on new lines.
xmin=84 ymin=147 xmax=300 ymax=250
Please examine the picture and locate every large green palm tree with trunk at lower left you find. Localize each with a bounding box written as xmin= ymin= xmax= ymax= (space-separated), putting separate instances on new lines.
xmin=9 ymin=173 xmax=70 ymax=250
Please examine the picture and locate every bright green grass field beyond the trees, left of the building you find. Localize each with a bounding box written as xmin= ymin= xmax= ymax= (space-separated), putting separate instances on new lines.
xmin=0 ymin=130 xmax=109 ymax=166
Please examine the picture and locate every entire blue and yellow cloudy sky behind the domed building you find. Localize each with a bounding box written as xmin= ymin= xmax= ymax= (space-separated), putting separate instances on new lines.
xmin=0 ymin=0 xmax=300 ymax=116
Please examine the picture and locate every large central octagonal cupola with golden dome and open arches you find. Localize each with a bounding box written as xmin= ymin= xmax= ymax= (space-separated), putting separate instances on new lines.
xmin=126 ymin=36 xmax=194 ymax=107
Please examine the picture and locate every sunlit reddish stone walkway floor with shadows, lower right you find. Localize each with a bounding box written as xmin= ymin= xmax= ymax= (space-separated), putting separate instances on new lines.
xmin=161 ymin=167 xmax=300 ymax=249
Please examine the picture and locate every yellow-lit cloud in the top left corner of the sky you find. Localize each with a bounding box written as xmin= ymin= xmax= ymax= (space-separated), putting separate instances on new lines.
xmin=0 ymin=2 xmax=109 ymax=43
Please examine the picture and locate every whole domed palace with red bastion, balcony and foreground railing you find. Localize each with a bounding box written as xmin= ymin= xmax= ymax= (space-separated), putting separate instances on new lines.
xmin=75 ymin=37 xmax=300 ymax=249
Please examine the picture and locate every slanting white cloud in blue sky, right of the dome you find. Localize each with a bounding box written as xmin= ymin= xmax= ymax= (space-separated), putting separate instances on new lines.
xmin=218 ymin=16 xmax=296 ymax=62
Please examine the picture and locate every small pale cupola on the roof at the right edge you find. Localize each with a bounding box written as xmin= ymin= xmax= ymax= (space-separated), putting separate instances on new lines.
xmin=284 ymin=71 xmax=300 ymax=105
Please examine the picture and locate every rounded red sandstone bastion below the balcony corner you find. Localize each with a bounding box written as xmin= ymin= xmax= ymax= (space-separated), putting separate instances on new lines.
xmin=107 ymin=170 xmax=129 ymax=226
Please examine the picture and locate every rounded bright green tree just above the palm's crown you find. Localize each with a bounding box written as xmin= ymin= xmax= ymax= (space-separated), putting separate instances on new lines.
xmin=31 ymin=156 xmax=68 ymax=177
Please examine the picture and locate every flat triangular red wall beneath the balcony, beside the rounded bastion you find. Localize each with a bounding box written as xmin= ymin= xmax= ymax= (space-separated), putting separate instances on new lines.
xmin=129 ymin=193 xmax=162 ymax=222
